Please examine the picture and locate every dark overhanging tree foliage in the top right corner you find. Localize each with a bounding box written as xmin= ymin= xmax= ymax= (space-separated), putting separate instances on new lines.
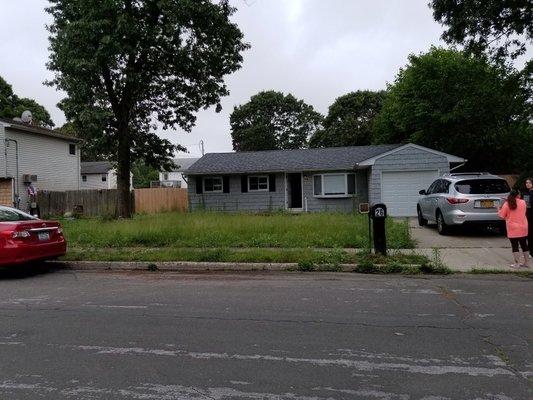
xmin=430 ymin=0 xmax=533 ymax=60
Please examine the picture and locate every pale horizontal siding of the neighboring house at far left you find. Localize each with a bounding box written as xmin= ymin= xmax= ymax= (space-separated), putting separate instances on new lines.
xmin=5 ymin=128 xmax=81 ymax=210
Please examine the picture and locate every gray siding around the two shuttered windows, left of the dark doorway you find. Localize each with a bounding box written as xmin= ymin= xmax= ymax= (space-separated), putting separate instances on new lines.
xmin=188 ymin=174 xmax=285 ymax=212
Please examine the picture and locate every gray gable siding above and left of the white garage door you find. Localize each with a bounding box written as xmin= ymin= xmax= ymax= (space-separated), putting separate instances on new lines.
xmin=368 ymin=147 xmax=450 ymax=203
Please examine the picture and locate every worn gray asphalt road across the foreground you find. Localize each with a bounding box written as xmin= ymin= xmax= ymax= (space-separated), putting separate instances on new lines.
xmin=0 ymin=269 xmax=533 ymax=400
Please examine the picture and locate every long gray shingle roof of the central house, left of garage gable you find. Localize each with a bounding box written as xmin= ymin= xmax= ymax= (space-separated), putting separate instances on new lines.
xmin=187 ymin=144 xmax=401 ymax=175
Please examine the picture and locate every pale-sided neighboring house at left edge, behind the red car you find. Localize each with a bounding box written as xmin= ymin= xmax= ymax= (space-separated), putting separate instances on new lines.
xmin=0 ymin=119 xmax=81 ymax=210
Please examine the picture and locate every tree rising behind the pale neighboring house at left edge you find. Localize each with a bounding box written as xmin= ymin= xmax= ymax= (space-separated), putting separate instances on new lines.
xmin=0 ymin=76 xmax=54 ymax=128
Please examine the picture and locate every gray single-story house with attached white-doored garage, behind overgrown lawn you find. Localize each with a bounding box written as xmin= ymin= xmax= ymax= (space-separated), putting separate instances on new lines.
xmin=187 ymin=144 xmax=466 ymax=216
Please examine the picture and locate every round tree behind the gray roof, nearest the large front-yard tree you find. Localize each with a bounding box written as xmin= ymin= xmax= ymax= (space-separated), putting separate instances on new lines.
xmin=230 ymin=90 xmax=322 ymax=151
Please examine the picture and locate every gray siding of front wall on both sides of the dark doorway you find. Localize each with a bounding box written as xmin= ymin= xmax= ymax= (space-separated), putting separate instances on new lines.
xmin=188 ymin=170 xmax=368 ymax=212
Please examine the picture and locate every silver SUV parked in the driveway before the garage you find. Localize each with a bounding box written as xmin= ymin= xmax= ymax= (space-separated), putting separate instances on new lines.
xmin=417 ymin=172 xmax=511 ymax=235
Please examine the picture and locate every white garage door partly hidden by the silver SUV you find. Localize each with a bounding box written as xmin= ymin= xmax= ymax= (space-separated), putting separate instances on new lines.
xmin=381 ymin=170 xmax=439 ymax=217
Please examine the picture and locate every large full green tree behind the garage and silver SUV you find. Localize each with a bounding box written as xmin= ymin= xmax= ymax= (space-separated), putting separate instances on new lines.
xmin=374 ymin=48 xmax=532 ymax=172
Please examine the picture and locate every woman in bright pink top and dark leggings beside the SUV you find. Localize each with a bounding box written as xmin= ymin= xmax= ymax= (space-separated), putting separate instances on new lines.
xmin=498 ymin=190 xmax=529 ymax=268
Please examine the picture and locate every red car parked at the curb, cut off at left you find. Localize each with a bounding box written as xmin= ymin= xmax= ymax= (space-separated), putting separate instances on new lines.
xmin=0 ymin=206 xmax=67 ymax=266
